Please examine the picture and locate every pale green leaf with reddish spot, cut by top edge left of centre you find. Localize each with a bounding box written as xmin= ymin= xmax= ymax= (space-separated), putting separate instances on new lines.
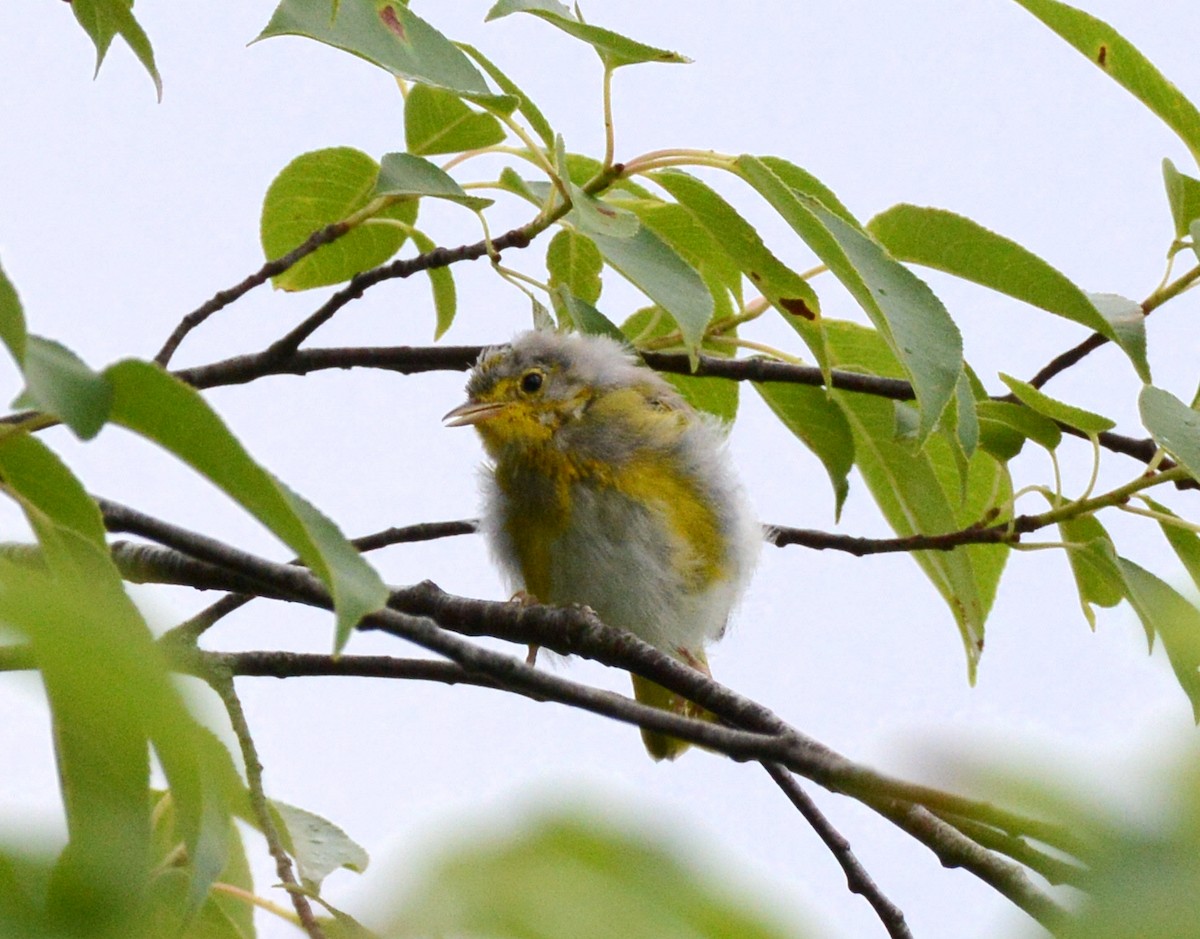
xmin=254 ymin=0 xmax=517 ymax=113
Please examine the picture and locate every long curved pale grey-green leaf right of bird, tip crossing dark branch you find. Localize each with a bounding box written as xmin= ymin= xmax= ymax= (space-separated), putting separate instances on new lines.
xmin=736 ymin=156 xmax=962 ymax=441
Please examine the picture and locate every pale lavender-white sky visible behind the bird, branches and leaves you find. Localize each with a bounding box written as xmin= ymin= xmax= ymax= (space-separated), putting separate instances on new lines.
xmin=0 ymin=0 xmax=1200 ymax=939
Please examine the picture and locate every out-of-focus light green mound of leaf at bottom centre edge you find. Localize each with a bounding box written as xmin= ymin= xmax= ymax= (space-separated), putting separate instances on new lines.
xmin=388 ymin=815 xmax=798 ymax=939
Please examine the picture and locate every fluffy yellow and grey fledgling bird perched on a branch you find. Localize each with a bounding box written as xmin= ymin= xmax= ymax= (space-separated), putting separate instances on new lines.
xmin=444 ymin=329 xmax=762 ymax=761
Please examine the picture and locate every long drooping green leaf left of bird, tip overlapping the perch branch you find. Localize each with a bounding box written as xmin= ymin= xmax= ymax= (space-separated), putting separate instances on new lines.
xmin=104 ymin=360 xmax=388 ymax=651
